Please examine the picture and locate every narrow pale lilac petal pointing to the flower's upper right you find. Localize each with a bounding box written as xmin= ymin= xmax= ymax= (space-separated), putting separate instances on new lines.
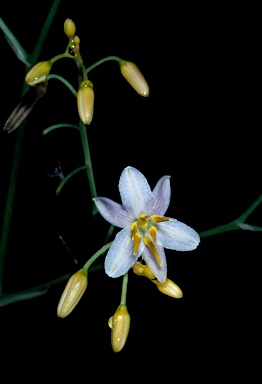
xmin=151 ymin=176 xmax=171 ymax=216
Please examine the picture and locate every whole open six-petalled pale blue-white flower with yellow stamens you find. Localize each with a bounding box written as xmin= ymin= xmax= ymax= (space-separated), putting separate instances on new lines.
xmin=94 ymin=167 xmax=200 ymax=283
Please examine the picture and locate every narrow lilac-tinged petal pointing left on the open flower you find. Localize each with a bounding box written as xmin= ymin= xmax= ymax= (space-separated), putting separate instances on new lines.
xmin=93 ymin=197 xmax=132 ymax=228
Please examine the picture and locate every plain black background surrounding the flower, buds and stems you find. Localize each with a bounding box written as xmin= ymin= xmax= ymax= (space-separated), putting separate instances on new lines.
xmin=0 ymin=1 xmax=261 ymax=382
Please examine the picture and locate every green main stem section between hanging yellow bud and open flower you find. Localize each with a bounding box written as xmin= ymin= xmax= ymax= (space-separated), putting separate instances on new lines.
xmin=79 ymin=121 xmax=98 ymax=215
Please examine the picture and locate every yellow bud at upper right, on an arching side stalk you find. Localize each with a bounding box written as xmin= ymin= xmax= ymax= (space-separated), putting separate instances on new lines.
xmin=119 ymin=60 xmax=149 ymax=97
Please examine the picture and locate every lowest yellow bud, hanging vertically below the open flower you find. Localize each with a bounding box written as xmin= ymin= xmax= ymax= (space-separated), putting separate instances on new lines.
xmin=108 ymin=304 xmax=130 ymax=352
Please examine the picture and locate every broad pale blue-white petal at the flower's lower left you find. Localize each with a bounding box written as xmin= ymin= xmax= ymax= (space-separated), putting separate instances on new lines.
xmin=105 ymin=227 xmax=143 ymax=277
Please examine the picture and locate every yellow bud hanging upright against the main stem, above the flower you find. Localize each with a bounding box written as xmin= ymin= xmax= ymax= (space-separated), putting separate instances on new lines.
xmin=77 ymin=80 xmax=95 ymax=125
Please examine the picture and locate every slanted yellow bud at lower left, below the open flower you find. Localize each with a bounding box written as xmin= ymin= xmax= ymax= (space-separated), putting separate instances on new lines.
xmin=57 ymin=268 xmax=87 ymax=317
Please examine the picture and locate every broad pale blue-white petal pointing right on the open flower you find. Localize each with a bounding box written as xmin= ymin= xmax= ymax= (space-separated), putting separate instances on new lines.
xmin=156 ymin=219 xmax=200 ymax=251
